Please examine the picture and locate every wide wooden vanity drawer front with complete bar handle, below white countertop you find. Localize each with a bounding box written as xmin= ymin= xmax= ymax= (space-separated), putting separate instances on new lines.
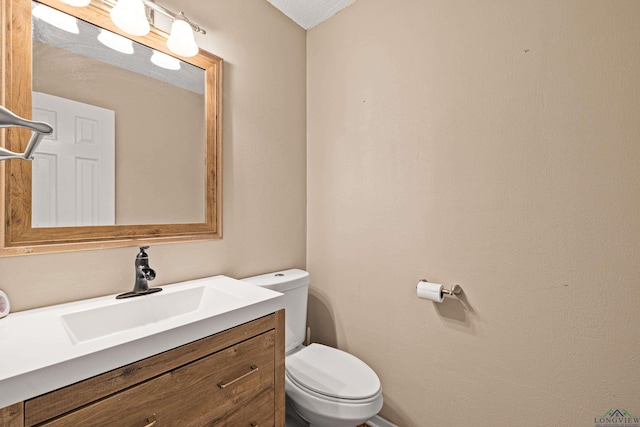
xmin=43 ymin=331 xmax=275 ymax=427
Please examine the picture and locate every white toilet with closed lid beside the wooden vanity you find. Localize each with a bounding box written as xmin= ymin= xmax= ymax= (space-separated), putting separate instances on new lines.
xmin=242 ymin=269 xmax=382 ymax=427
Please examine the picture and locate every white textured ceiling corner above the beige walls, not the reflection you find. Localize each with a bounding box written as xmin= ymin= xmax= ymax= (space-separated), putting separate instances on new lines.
xmin=267 ymin=0 xmax=356 ymax=30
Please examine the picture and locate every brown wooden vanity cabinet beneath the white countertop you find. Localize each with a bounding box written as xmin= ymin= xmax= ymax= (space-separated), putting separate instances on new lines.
xmin=0 ymin=310 xmax=285 ymax=427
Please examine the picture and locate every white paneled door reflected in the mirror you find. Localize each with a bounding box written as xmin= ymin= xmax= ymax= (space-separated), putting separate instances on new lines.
xmin=32 ymin=92 xmax=115 ymax=227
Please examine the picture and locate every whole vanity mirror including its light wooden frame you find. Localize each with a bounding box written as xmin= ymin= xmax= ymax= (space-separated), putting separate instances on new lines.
xmin=3 ymin=0 xmax=222 ymax=253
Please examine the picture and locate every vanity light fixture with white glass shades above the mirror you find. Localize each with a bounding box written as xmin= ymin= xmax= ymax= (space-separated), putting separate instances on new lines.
xmin=60 ymin=0 xmax=207 ymax=58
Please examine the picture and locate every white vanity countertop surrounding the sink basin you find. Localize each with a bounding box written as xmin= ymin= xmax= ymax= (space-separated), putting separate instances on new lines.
xmin=0 ymin=276 xmax=284 ymax=408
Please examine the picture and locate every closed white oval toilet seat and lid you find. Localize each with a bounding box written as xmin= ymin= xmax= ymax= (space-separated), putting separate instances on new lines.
xmin=285 ymin=343 xmax=380 ymax=403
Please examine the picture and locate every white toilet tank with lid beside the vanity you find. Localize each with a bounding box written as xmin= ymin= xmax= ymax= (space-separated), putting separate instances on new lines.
xmin=242 ymin=268 xmax=310 ymax=353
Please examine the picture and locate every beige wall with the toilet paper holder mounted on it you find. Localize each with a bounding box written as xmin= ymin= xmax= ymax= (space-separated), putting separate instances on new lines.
xmin=307 ymin=0 xmax=640 ymax=426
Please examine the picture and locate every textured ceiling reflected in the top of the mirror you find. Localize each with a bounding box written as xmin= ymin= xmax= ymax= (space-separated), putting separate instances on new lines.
xmin=33 ymin=6 xmax=204 ymax=94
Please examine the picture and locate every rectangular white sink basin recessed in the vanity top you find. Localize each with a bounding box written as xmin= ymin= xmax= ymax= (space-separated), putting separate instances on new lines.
xmin=60 ymin=286 xmax=240 ymax=344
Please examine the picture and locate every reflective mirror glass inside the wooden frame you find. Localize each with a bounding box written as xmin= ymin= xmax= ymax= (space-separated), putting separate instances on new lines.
xmin=31 ymin=1 xmax=205 ymax=227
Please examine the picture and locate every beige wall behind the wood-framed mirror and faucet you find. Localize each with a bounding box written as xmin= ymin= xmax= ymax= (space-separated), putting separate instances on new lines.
xmin=0 ymin=0 xmax=306 ymax=311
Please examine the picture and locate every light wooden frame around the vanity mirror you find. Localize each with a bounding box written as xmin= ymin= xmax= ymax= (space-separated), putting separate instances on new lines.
xmin=0 ymin=0 xmax=223 ymax=256
